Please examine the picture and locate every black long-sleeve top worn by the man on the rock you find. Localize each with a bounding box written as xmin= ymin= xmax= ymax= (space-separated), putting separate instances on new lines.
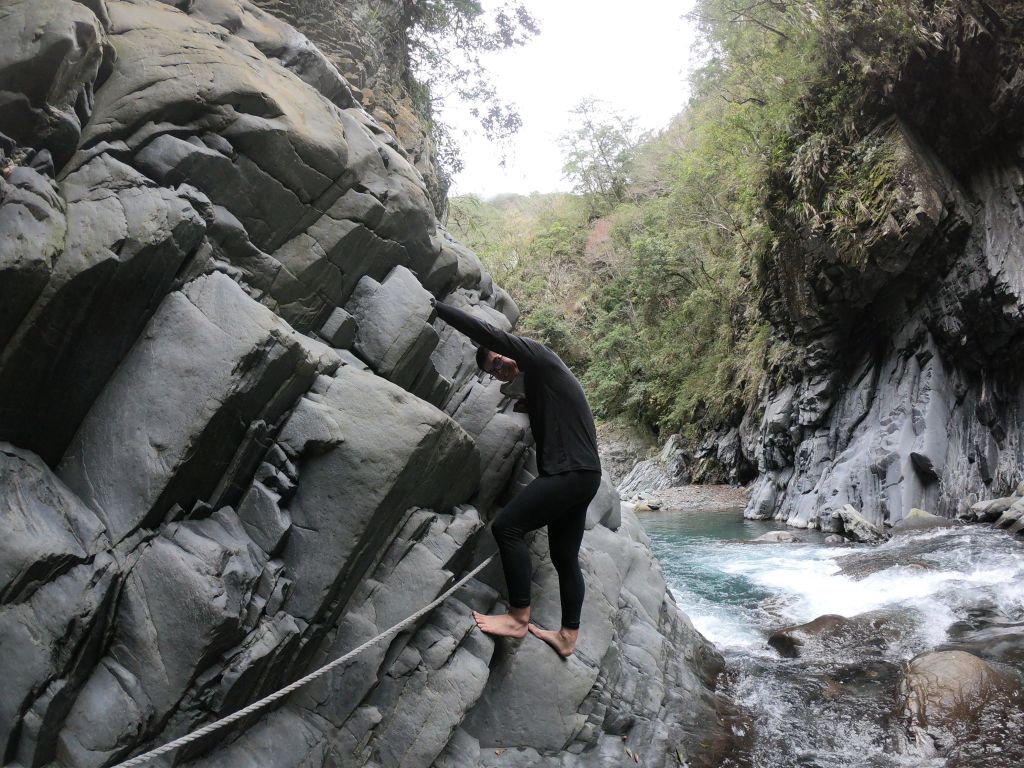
xmin=435 ymin=303 xmax=601 ymax=475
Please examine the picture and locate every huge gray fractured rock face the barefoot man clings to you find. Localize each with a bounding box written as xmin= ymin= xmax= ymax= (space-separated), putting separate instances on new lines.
xmin=0 ymin=0 xmax=723 ymax=768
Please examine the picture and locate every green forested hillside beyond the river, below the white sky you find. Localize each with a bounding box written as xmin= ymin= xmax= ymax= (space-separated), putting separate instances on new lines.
xmin=449 ymin=0 xmax=957 ymax=442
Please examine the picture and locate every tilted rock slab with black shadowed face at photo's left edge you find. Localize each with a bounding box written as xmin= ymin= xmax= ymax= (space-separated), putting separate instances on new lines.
xmin=0 ymin=156 xmax=205 ymax=464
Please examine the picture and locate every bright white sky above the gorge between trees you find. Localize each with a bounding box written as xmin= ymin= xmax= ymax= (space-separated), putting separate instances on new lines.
xmin=443 ymin=0 xmax=695 ymax=197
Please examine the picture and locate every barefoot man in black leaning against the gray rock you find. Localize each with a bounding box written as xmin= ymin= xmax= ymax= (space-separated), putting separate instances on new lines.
xmin=434 ymin=296 xmax=601 ymax=657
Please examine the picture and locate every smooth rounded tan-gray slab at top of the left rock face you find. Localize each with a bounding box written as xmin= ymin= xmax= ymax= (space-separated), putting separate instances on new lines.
xmin=73 ymin=3 xmax=351 ymax=253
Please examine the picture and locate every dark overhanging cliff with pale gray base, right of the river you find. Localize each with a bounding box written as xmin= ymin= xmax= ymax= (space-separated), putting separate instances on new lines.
xmin=746 ymin=2 xmax=1024 ymax=527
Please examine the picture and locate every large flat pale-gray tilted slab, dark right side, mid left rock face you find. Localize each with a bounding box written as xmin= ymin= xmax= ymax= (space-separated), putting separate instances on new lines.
xmin=58 ymin=273 xmax=330 ymax=540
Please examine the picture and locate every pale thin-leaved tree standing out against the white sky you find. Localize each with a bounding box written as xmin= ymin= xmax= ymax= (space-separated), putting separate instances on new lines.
xmin=559 ymin=97 xmax=639 ymax=214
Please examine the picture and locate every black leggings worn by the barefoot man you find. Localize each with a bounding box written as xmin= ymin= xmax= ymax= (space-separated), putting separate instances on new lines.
xmin=490 ymin=470 xmax=601 ymax=630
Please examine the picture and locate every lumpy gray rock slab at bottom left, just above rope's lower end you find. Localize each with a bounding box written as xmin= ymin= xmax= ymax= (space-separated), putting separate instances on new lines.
xmin=63 ymin=513 xmax=265 ymax=764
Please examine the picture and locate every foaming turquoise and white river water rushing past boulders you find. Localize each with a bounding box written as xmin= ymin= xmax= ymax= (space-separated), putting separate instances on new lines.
xmin=641 ymin=510 xmax=1024 ymax=768
